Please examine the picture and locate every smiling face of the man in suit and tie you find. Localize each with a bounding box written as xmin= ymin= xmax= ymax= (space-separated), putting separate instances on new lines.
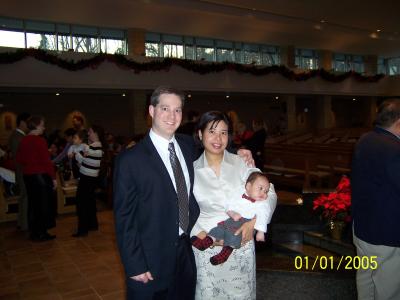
xmin=149 ymin=94 xmax=182 ymax=140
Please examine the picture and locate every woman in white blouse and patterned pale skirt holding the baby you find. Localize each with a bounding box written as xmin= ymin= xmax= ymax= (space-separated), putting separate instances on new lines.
xmin=191 ymin=111 xmax=277 ymax=300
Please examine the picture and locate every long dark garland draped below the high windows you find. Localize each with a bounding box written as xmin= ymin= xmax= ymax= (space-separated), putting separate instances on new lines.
xmin=0 ymin=48 xmax=384 ymax=82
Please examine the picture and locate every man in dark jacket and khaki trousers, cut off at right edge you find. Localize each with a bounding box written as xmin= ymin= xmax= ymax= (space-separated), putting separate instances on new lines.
xmin=351 ymin=99 xmax=400 ymax=300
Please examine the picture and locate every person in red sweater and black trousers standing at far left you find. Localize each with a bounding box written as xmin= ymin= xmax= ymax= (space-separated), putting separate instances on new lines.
xmin=16 ymin=116 xmax=57 ymax=242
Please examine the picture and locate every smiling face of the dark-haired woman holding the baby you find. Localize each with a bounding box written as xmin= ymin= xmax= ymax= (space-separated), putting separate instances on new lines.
xmin=199 ymin=121 xmax=228 ymax=155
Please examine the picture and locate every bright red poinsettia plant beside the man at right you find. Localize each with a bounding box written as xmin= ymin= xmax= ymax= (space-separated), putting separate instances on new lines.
xmin=313 ymin=176 xmax=351 ymax=222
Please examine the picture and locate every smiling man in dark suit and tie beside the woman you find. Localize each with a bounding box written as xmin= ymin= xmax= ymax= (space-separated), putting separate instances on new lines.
xmin=114 ymin=87 xmax=199 ymax=300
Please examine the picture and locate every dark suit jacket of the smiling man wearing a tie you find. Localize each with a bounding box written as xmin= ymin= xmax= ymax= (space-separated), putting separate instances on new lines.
xmin=114 ymin=134 xmax=200 ymax=290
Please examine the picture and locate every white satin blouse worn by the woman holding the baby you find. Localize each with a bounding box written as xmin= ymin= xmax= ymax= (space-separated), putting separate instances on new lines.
xmin=191 ymin=151 xmax=277 ymax=236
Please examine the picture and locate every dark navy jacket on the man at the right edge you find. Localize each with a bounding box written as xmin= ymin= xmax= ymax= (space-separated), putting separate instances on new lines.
xmin=351 ymin=128 xmax=400 ymax=247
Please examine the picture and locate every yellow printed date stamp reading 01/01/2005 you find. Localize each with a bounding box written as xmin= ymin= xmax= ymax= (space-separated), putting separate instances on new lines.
xmin=294 ymin=255 xmax=378 ymax=271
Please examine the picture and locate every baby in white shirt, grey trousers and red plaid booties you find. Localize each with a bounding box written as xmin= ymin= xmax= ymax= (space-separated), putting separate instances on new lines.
xmin=191 ymin=172 xmax=271 ymax=265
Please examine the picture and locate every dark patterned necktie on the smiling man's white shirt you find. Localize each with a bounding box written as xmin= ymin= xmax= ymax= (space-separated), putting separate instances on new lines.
xmin=168 ymin=143 xmax=189 ymax=232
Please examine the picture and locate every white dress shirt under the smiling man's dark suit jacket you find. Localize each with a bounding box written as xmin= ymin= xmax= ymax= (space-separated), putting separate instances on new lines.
xmin=149 ymin=129 xmax=190 ymax=235
